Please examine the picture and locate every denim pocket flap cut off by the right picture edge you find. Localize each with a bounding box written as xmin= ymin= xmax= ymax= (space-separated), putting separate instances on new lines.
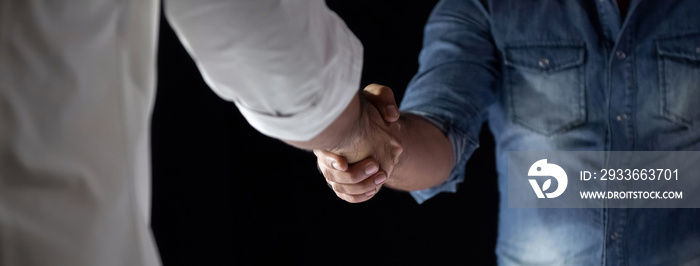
xmin=656 ymin=32 xmax=700 ymax=61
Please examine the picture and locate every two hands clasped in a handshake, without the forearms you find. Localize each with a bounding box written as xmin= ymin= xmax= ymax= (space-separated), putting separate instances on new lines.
xmin=314 ymin=84 xmax=403 ymax=203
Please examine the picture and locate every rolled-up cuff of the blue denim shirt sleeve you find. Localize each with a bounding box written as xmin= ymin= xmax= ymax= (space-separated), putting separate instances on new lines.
xmin=405 ymin=110 xmax=479 ymax=204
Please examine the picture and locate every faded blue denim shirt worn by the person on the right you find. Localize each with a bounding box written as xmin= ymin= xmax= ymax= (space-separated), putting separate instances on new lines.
xmin=401 ymin=0 xmax=700 ymax=265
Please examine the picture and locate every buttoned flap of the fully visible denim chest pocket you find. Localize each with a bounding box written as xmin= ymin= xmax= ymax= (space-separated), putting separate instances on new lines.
xmin=505 ymin=42 xmax=585 ymax=72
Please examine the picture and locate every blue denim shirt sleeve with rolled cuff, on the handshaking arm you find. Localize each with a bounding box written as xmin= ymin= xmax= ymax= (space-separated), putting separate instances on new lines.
xmin=401 ymin=0 xmax=500 ymax=203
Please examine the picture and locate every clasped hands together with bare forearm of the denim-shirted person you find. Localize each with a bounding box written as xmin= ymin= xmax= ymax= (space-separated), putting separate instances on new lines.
xmin=300 ymin=84 xmax=454 ymax=203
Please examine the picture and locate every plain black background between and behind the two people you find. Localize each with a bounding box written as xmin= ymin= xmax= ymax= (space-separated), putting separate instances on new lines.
xmin=152 ymin=0 xmax=498 ymax=266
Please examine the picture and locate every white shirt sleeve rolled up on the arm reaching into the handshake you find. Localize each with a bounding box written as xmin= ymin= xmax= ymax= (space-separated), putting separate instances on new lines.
xmin=165 ymin=0 xmax=362 ymax=141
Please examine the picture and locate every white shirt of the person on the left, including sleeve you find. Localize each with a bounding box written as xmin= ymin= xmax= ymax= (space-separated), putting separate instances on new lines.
xmin=0 ymin=0 xmax=362 ymax=266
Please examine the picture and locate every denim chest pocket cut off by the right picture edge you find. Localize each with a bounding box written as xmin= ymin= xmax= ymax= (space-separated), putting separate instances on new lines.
xmin=656 ymin=32 xmax=700 ymax=128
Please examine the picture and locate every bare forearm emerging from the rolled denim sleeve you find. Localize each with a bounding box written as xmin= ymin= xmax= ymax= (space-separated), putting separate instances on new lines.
xmin=385 ymin=114 xmax=454 ymax=191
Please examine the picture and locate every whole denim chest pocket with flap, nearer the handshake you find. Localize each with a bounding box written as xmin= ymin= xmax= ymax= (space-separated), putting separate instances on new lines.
xmin=504 ymin=42 xmax=586 ymax=136
